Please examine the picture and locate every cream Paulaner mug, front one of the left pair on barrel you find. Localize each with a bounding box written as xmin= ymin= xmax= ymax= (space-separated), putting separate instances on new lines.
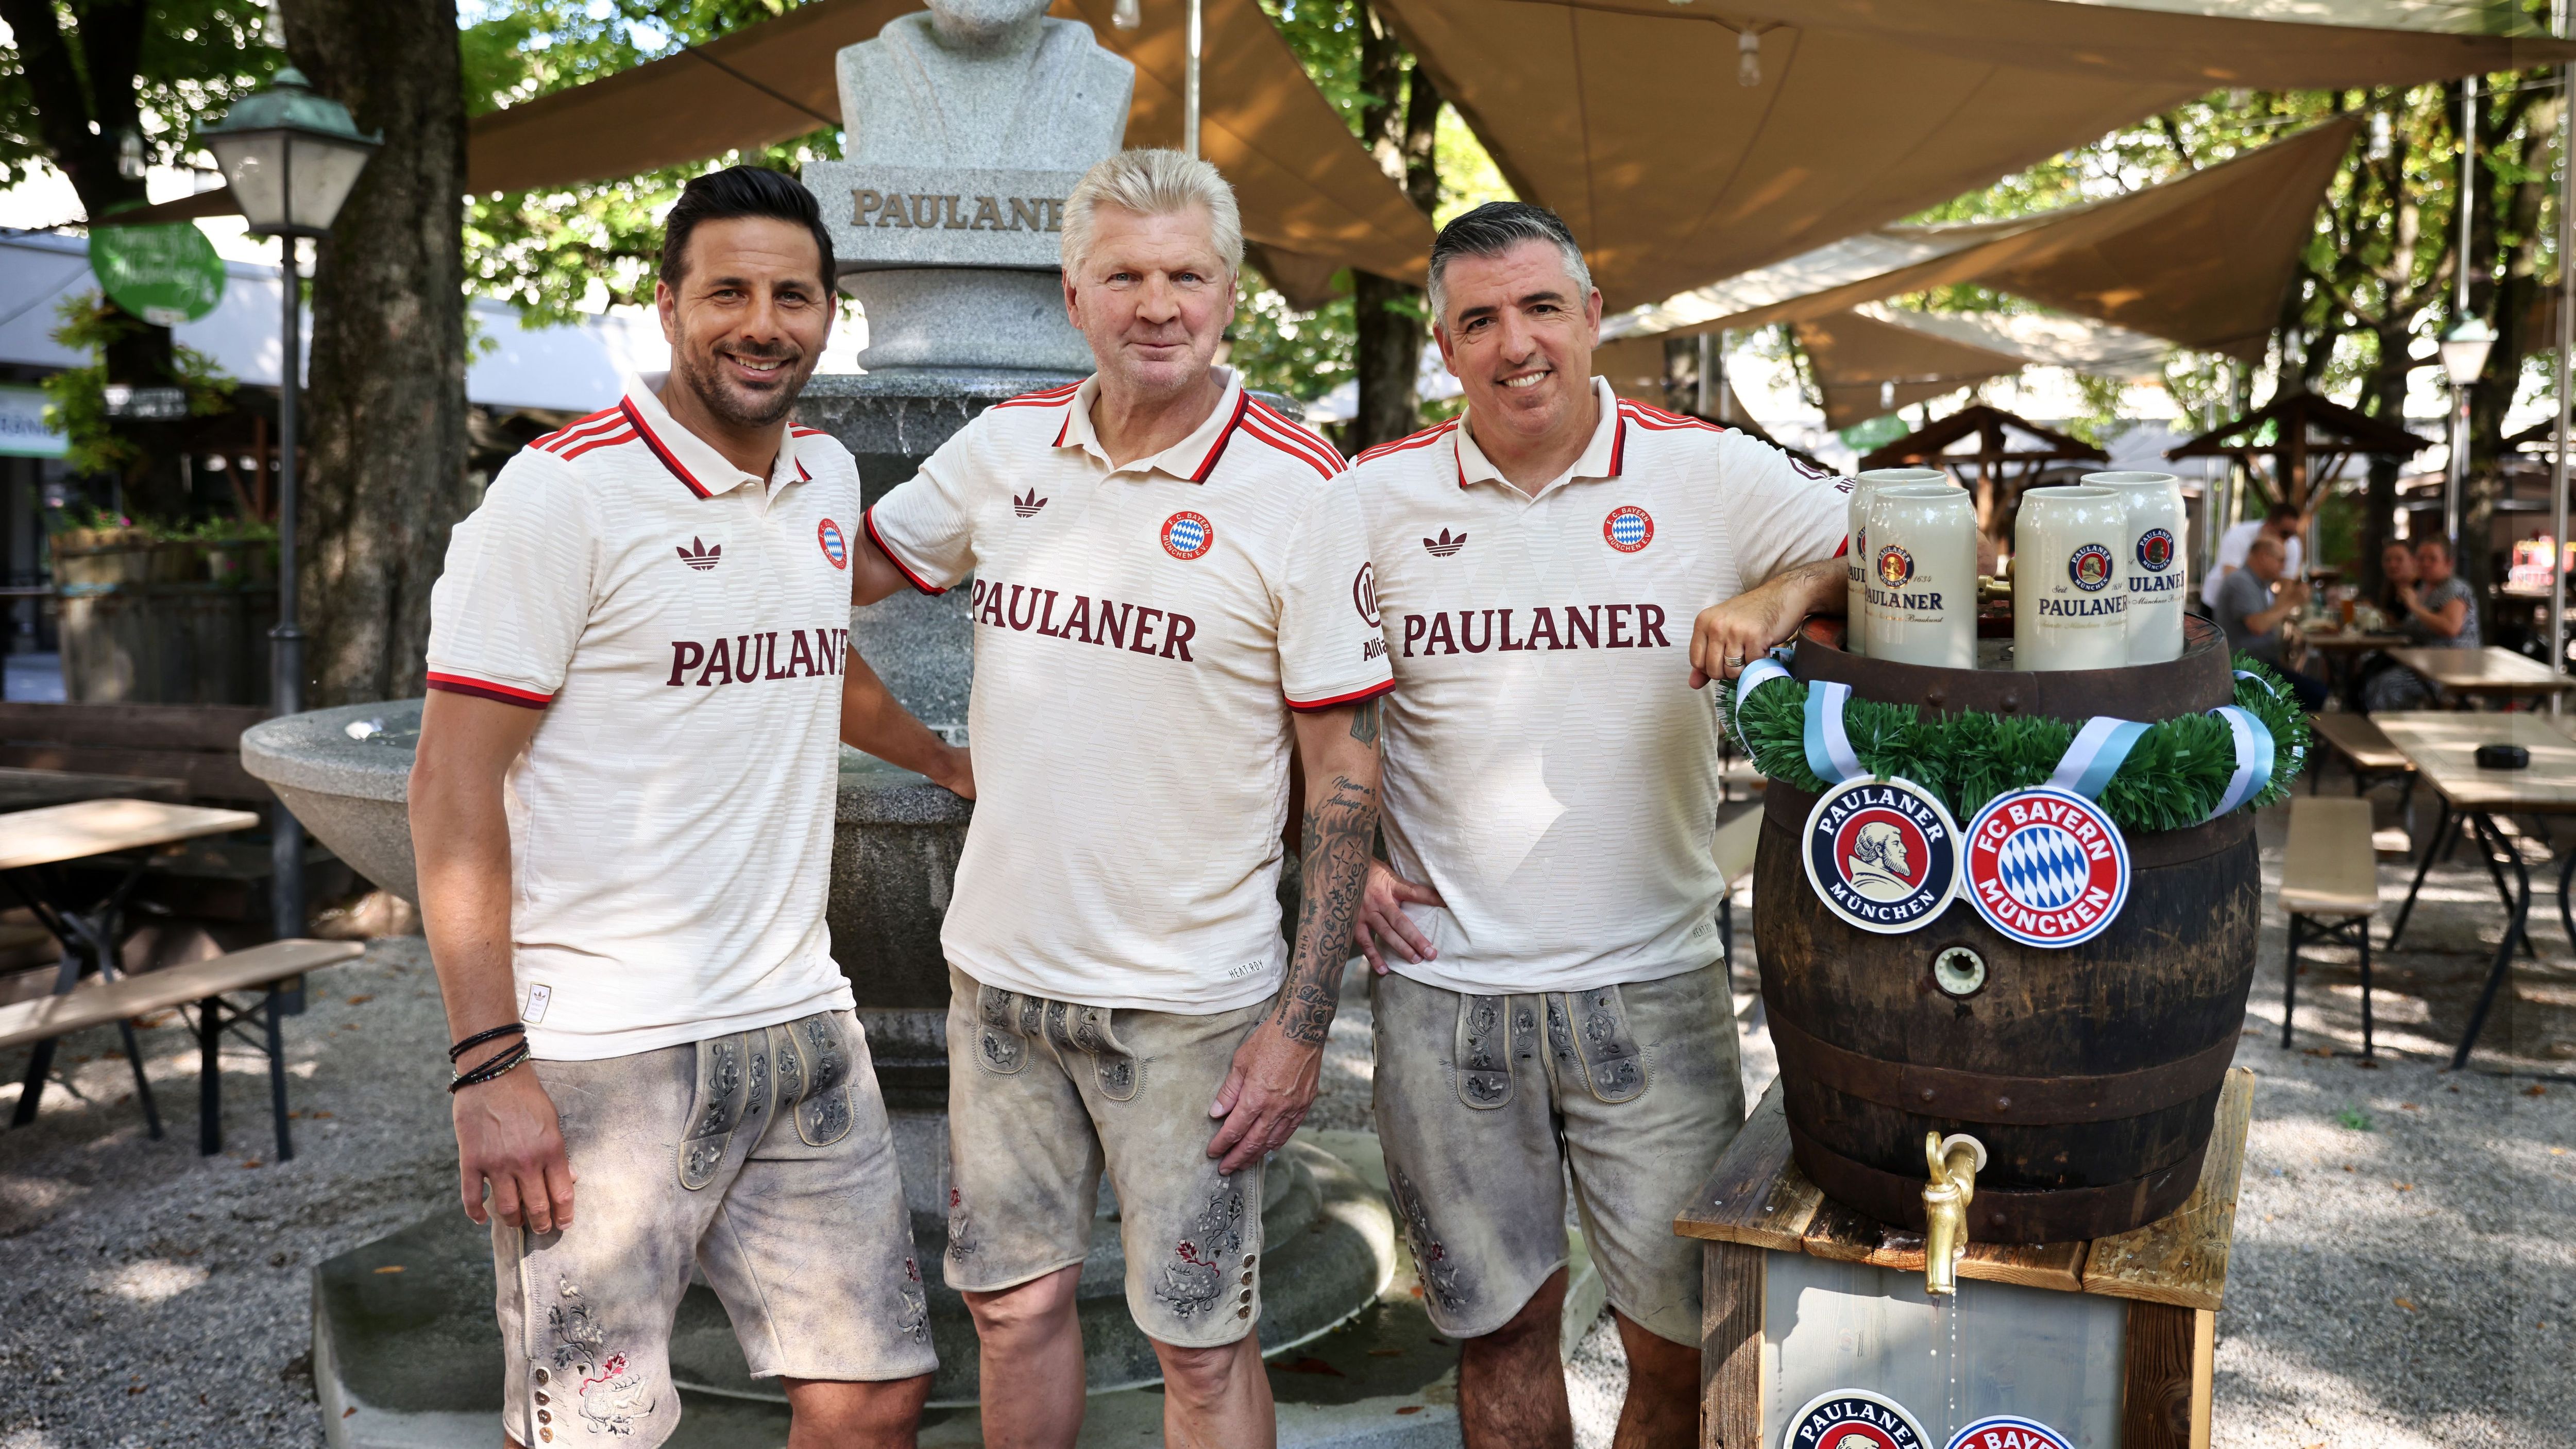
xmin=1868 ymin=484 xmax=1976 ymax=669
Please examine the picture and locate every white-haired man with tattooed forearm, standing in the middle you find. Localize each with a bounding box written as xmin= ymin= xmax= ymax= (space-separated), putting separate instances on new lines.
xmin=855 ymin=152 xmax=1391 ymax=1449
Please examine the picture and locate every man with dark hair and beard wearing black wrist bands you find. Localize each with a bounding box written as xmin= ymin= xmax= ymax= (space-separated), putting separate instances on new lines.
xmin=410 ymin=167 xmax=974 ymax=1449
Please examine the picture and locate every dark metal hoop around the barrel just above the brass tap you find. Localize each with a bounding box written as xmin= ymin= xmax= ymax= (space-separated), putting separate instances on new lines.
xmin=1770 ymin=1009 xmax=2236 ymax=1127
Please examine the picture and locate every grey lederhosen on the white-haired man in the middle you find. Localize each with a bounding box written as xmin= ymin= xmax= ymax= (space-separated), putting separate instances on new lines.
xmin=948 ymin=965 xmax=1270 ymax=1349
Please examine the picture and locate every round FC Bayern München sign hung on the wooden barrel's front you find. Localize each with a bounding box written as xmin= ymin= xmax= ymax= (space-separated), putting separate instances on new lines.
xmin=1963 ymin=785 xmax=2130 ymax=947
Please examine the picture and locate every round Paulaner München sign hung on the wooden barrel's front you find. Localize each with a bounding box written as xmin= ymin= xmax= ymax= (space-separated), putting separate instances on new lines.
xmin=1806 ymin=777 xmax=1958 ymax=937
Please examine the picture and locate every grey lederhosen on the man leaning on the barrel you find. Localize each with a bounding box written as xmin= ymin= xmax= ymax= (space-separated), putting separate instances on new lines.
xmin=1370 ymin=968 xmax=1744 ymax=1343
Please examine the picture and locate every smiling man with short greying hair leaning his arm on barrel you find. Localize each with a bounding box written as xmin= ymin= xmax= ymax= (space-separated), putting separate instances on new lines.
xmin=1350 ymin=201 xmax=1850 ymax=1449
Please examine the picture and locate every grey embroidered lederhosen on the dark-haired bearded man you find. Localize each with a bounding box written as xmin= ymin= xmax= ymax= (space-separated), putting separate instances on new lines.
xmin=492 ymin=1012 xmax=938 ymax=1449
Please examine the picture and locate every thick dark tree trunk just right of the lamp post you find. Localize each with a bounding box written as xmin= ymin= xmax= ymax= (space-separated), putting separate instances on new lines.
xmin=286 ymin=0 xmax=466 ymax=705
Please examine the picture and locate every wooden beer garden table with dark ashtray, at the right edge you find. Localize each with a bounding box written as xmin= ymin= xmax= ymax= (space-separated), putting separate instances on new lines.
xmin=2370 ymin=715 xmax=2576 ymax=1071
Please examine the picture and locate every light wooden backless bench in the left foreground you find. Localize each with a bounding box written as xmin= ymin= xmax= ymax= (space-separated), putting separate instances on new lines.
xmin=0 ymin=940 xmax=366 ymax=1161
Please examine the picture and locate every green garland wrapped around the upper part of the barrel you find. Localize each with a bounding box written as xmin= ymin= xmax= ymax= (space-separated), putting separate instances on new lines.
xmin=1721 ymin=654 xmax=2308 ymax=834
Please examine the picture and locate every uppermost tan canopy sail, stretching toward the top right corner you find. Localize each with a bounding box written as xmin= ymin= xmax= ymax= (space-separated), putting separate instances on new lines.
xmin=1381 ymin=0 xmax=2576 ymax=309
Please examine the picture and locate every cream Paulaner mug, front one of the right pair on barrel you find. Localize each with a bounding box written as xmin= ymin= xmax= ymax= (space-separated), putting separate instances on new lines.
xmin=2012 ymin=486 xmax=2128 ymax=669
